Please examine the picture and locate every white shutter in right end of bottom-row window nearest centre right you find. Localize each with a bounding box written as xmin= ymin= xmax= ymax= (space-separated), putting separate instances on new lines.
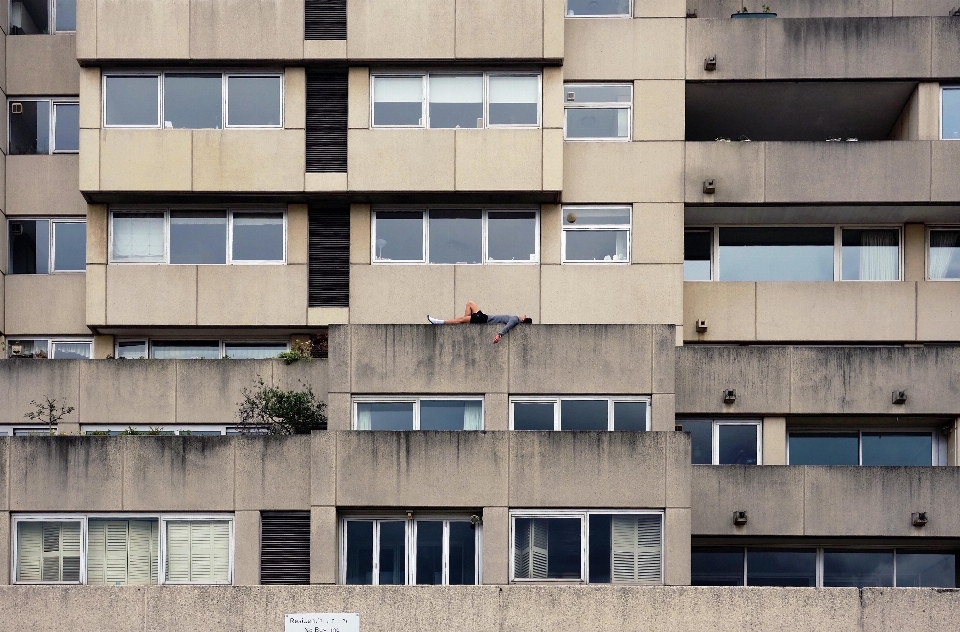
xmin=610 ymin=515 xmax=662 ymax=584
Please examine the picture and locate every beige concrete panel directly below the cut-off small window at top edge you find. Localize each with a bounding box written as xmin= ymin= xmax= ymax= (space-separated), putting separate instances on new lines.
xmin=563 ymin=18 xmax=686 ymax=81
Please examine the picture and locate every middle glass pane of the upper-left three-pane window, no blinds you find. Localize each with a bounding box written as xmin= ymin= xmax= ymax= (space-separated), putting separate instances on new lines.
xmin=163 ymin=73 xmax=223 ymax=129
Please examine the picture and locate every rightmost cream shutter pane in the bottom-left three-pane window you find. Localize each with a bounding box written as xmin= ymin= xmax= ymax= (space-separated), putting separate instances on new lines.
xmin=166 ymin=520 xmax=230 ymax=584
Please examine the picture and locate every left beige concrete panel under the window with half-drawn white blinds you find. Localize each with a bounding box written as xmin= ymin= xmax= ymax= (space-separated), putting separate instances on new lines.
xmin=347 ymin=130 xmax=456 ymax=191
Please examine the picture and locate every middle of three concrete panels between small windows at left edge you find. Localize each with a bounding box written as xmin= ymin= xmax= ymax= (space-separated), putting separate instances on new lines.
xmin=5 ymin=154 xmax=87 ymax=215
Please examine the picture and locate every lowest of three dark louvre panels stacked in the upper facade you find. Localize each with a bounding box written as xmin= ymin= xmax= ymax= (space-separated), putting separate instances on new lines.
xmin=308 ymin=207 xmax=350 ymax=307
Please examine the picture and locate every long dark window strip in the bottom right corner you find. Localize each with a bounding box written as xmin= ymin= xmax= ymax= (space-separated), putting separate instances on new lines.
xmin=690 ymin=547 xmax=958 ymax=588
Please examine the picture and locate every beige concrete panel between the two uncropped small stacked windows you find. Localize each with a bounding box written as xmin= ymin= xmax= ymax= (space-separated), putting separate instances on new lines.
xmin=563 ymin=142 xmax=683 ymax=203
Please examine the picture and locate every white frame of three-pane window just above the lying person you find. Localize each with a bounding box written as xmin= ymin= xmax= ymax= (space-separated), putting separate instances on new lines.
xmin=370 ymin=205 xmax=540 ymax=266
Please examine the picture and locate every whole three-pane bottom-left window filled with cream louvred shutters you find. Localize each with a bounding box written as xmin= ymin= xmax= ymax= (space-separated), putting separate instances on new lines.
xmin=13 ymin=515 xmax=233 ymax=586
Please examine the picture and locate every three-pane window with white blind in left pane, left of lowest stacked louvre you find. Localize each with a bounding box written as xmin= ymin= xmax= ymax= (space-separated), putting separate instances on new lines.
xmin=110 ymin=210 xmax=287 ymax=265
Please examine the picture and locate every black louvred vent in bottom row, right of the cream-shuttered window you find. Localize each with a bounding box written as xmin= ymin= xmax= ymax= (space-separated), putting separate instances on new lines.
xmin=260 ymin=511 xmax=310 ymax=585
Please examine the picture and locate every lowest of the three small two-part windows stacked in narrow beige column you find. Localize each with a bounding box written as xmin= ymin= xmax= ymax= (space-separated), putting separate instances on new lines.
xmin=562 ymin=206 xmax=631 ymax=263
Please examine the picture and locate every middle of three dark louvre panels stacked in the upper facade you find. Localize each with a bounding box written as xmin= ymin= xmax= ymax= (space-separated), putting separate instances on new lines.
xmin=307 ymin=71 xmax=347 ymax=173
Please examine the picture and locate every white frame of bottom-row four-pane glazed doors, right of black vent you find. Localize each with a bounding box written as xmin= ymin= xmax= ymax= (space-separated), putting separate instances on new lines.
xmin=338 ymin=511 xmax=483 ymax=586
